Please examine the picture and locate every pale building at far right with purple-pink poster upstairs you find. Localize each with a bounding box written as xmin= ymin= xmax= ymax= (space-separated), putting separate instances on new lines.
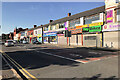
xmin=102 ymin=0 xmax=120 ymax=49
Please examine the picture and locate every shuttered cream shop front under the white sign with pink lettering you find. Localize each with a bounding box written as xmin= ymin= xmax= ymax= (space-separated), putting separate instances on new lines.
xmin=102 ymin=23 xmax=120 ymax=49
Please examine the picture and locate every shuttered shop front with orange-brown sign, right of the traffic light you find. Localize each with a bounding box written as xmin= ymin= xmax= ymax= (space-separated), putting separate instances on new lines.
xmin=69 ymin=26 xmax=82 ymax=45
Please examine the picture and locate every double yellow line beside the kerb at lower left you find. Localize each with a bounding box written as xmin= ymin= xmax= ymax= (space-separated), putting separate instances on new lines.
xmin=0 ymin=50 xmax=38 ymax=80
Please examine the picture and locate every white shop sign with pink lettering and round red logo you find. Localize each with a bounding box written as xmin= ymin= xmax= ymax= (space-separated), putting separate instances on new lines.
xmin=102 ymin=24 xmax=120 ymax=31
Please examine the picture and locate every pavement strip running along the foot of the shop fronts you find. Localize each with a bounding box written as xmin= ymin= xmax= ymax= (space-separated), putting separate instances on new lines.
xmin=42 ymin=43 xmax=120 ymax=52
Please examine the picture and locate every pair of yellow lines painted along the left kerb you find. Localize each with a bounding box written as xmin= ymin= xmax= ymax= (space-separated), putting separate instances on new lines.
xmin=0 ymin=50 xmax=38 ymax=80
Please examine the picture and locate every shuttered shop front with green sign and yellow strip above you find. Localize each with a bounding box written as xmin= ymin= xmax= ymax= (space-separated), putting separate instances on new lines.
xmin=82 ymin=23 xmax=102 ymax=47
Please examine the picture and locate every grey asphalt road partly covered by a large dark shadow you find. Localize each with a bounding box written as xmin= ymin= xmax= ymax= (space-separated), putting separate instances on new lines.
xmin=2 ymin=44 xmax=118 ymax=80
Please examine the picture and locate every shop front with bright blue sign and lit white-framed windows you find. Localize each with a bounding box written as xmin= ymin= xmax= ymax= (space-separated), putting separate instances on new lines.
xmin=43 ymin=32 xmax=57 ymax=44
